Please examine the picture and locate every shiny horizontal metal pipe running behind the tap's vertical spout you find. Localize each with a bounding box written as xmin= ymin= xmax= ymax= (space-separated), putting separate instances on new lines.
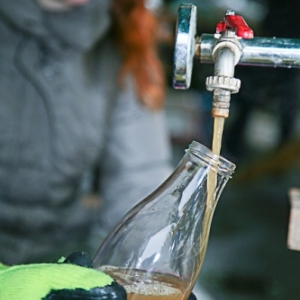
xmin=197 ymin=34 xmax=300 ymax=68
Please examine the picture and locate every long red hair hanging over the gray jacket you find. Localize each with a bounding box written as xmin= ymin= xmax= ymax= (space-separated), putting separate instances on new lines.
xmin=112 ymin=0 xmax=165 ymax=110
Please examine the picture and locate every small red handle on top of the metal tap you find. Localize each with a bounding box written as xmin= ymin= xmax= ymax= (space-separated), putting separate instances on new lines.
xmin=217 ymin=15 xmax=254 ymax=39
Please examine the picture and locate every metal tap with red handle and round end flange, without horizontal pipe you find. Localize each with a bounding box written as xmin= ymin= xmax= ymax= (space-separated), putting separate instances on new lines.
xmin=173 ymin=4 xmax=253 ymax=118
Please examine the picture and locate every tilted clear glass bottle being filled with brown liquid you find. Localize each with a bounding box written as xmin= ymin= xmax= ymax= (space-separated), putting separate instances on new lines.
xmin=94 ymin=142 xmax=235 ymax=300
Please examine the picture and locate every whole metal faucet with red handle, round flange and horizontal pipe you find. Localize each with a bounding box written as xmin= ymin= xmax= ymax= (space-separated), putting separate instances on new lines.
xmin=173 ymin=4 xmax=300 ymax=118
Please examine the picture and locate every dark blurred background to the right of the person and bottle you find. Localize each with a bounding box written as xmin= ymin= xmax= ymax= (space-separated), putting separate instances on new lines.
xmin=159 ymin=0 xmax=300 ymax=300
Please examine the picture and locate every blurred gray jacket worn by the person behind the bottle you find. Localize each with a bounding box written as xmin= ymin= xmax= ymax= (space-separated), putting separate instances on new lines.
xmin=0 ymin=0 xmax=171 ymax=263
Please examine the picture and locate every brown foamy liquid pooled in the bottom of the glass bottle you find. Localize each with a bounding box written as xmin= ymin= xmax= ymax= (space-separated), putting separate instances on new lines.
xmin=100 ymin=266 xmax=187 ymax=300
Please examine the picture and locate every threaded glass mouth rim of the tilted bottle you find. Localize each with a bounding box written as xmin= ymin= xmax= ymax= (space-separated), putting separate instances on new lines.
xmin=186 ymin=141 xmax=236 ymax=177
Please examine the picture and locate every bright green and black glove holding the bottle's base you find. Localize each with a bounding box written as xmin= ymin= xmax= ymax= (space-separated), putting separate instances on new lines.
xmin=0 ymin=252 xmax=127 ymax=300
